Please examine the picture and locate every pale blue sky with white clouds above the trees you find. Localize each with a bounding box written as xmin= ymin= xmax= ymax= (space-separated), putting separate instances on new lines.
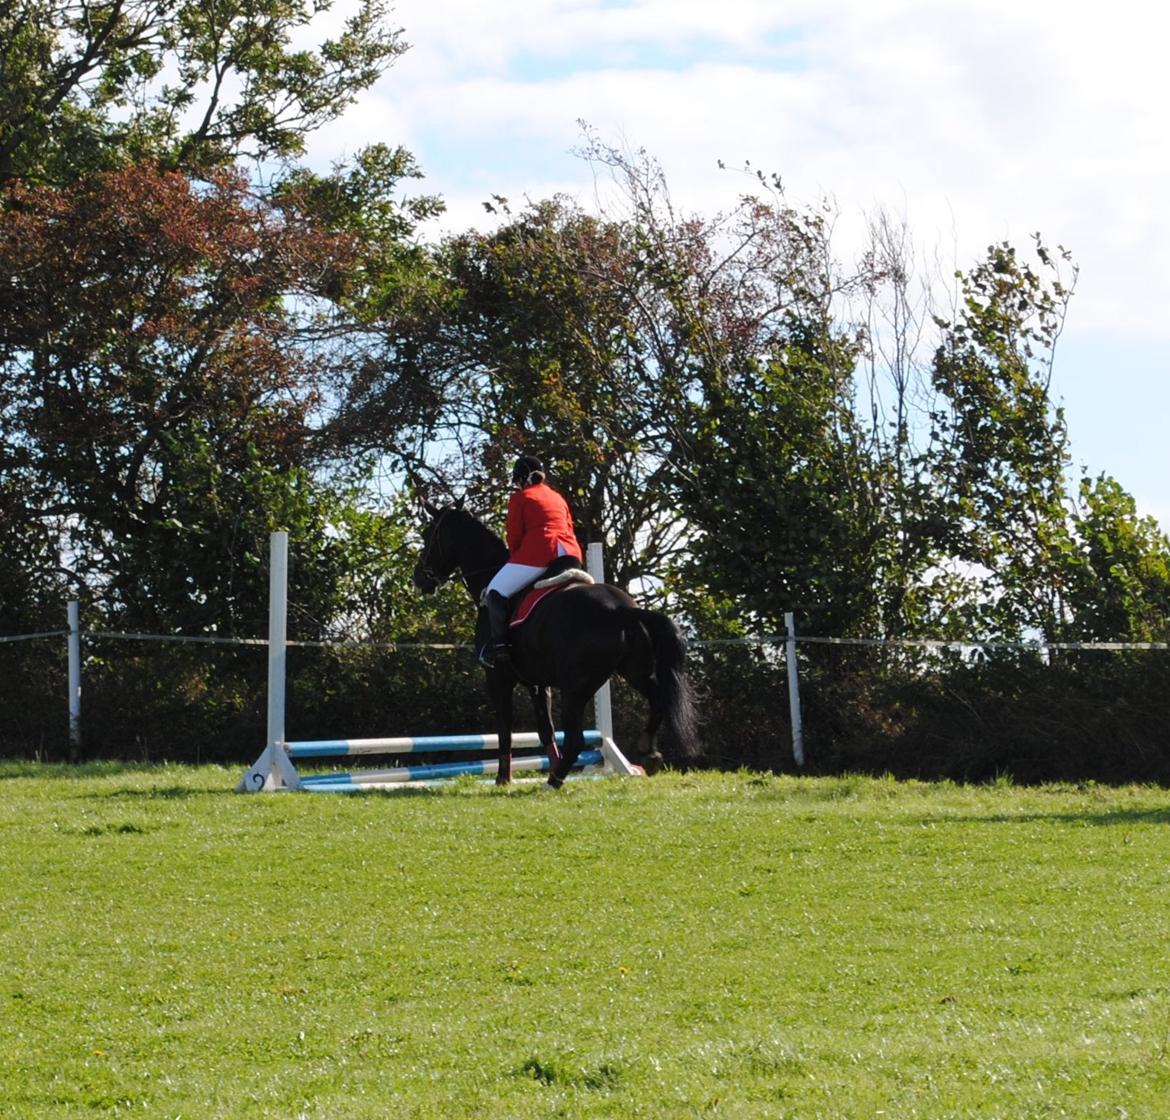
xmin=309 ymin=0 xmax=1170 ymax=531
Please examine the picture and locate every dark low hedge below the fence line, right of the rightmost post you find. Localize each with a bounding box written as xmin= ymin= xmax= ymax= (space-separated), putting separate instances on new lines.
xmin=808 ymin=651 xmax=1170 ymax=784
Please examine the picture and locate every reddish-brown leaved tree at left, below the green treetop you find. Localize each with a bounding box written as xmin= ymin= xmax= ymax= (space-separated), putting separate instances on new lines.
xmin=0 ymin=157 xmax=369 ymax=633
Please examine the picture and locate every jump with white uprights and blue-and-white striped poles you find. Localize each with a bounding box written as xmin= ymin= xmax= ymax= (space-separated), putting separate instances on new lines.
xmin=236 ymin=532 xmax=644 ymax=792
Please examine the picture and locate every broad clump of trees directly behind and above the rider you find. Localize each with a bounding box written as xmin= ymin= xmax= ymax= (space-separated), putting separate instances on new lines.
xmin=349 ymin=147 xmax=889 ymax=618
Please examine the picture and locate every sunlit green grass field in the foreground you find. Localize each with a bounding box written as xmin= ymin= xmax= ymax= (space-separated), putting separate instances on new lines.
xmin=0 ymin=763 xmax=1170 ymax=1120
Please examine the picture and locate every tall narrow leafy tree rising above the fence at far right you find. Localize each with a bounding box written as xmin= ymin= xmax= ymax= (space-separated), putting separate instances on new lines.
xmin=931 ymin=238 xmax=1073 ymax=639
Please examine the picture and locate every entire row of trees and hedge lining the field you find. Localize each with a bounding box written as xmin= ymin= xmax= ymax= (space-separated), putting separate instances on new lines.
xmin=9 ymin=23 xmax=1170 ymax=777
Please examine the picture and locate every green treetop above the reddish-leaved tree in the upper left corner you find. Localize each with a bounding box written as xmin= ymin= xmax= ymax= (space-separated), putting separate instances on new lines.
xmin=0 ymin=0 xmax=405 ymax=184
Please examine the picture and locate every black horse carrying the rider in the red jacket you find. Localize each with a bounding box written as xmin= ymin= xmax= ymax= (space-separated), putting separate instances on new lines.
xmin=414 ymin=501 xmax=697 ymax=789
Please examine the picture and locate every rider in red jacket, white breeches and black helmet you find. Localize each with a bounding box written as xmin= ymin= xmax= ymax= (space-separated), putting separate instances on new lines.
xmin=480 ymin=455 xmax=581 ymax=665
